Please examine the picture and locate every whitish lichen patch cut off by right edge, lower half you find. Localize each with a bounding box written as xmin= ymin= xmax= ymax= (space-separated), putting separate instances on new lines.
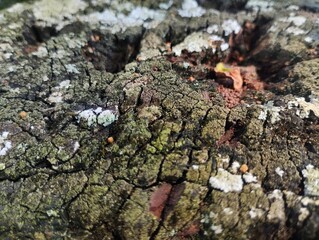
xmin=301 ymin=164 xmax=319 ymax=196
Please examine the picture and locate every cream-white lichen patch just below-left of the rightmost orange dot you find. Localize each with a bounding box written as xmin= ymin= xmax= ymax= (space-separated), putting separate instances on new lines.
xmin=209 ymin=168 xmax=243 ymax=193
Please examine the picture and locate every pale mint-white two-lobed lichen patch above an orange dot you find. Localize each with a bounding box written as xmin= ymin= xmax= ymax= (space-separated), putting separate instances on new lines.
xmin=78 ymin=107 xmax=118 ymax=127
